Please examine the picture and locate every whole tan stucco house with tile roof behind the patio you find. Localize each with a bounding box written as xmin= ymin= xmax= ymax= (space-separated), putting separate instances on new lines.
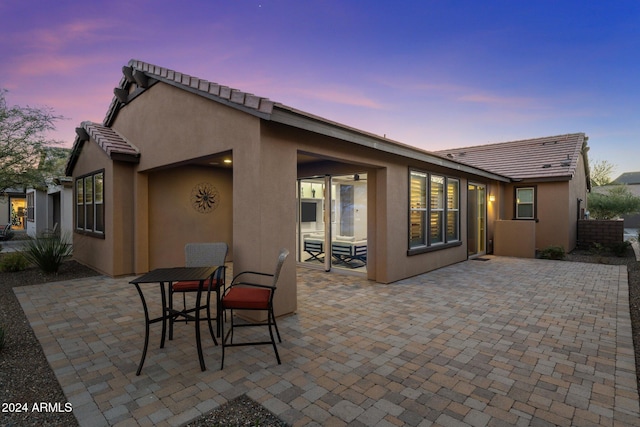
xmin=66 ymin=60 xmax=588 ymax=315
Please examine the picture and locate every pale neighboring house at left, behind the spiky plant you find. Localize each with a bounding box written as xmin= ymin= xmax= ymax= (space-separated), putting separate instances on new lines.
xmin=25 ymin=177 xmax=74 ymax=237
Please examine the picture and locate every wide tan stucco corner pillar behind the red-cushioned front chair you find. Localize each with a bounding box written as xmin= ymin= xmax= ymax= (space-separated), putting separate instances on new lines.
xmin=233 ymin=125 xmax=297 ymax=315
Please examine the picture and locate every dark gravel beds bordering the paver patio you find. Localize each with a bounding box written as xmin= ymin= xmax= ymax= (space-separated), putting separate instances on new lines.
xmin=0 ymin=249 xmax=640 ymax=427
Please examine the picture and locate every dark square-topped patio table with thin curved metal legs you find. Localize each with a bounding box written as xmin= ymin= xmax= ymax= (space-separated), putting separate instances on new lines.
xmin=129 ymin=266 xmax=224 ymax=375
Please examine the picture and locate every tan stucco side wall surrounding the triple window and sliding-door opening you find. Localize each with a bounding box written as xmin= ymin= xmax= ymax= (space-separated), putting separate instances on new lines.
xmin=264 ymin=124 xmax=476 ymax=283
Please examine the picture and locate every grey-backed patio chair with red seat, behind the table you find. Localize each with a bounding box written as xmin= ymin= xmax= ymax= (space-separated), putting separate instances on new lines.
xmin=169 ymin=242 xmax=228 ymax=340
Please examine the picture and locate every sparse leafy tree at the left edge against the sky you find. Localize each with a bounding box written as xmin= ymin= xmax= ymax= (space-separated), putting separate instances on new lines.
xmin=0 ymin=89 xmax=62 ymax=194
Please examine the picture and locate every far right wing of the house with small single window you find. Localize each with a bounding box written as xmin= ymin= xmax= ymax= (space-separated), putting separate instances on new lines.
xmin=437 ymin=133 xmax=591 ymax=256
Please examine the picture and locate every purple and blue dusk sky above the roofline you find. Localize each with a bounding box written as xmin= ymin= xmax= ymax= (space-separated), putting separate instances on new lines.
xmin=0 ymin=0 xmax=640 ymax=178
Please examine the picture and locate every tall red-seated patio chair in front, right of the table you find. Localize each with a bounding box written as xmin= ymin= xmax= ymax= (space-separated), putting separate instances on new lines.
xmin=220 ymin=249 xmax=289 ymax=369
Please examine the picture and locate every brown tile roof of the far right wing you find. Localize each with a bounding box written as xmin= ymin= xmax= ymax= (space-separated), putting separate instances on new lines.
xmin=434 ymin=133 xmax=588 ymax=179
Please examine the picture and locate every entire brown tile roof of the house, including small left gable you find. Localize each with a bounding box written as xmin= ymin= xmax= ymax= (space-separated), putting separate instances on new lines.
xmin=67 ymin=59 xmax=587 ymax=186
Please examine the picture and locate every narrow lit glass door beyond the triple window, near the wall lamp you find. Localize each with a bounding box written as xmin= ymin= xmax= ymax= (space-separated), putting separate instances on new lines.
xmin=467 ymin=183 xmax=487 ymax=258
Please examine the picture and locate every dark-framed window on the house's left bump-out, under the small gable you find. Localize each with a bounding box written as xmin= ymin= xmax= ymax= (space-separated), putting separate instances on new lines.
xmin=76 ymin=171 xmax=104 ymax=235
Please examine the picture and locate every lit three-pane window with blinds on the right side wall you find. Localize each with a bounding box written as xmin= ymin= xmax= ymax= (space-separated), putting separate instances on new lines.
xmin=409 ymin=171 xmax=460 ymax=250
